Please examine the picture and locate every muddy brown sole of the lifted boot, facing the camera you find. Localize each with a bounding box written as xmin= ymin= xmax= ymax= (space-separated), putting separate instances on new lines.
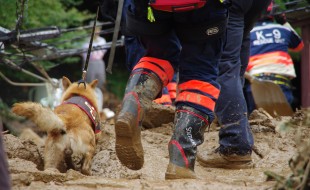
xmin=115 ymin=119 xmax=144 ymax=170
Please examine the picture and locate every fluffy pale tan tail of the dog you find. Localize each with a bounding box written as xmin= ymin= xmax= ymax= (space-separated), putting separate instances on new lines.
xmin=12 ymin=102 xmax=66 ymax=134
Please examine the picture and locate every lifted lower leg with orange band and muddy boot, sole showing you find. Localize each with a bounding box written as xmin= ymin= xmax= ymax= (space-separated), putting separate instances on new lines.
xmin=115 ymin=27 xmax=180 ymax=170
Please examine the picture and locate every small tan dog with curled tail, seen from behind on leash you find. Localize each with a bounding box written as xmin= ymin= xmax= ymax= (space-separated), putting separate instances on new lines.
xmin=12 ymin=77 xmax=100 ymax=175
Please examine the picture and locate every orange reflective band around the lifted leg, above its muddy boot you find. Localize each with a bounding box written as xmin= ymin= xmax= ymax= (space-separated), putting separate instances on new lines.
xmin=133 ymin=57 xmax=174 ymax=86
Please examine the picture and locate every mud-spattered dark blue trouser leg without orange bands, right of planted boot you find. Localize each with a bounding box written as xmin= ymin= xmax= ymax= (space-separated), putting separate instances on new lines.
xmin=215 ymin=1 xmax=254 ymax=155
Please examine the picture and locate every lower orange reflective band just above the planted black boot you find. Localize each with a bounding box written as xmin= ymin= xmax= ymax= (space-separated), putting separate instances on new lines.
xmin=176 ymin=91 xmax=215 ymax=111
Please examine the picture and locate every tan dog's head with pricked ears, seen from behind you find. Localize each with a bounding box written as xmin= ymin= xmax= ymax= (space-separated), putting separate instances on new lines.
xmin=61 ymin=76 xmax=98 ymax=110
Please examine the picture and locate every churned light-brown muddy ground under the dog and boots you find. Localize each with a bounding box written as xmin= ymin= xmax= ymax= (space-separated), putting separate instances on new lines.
xmin=4 ymin=102 xmax=310 ymax=190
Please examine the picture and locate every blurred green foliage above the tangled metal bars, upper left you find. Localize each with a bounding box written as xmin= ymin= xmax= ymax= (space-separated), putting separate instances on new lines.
xmin=0 ymin=0 xmax=91 ymax=29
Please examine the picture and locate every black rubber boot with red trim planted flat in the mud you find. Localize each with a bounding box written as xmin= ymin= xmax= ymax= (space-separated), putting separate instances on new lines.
xmin=165 ymin=106 xmax=209 ymax=179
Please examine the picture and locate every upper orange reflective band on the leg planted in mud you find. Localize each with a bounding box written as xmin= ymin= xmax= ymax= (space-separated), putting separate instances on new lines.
xmin=178 ymin=80 xmax=220 ymax=99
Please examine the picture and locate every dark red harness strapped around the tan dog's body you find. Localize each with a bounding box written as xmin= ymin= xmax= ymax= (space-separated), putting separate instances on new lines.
xmin=63 ymin=96 xmax=101 ymax=134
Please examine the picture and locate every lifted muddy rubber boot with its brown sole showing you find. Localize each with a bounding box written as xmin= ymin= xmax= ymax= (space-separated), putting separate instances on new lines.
xmin=115 ymin=69 xmax=163 ymax=170
